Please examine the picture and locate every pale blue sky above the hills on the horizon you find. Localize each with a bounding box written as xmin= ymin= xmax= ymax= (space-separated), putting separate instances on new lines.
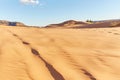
xmin=0 ymin=0 xmax=120 ymax=26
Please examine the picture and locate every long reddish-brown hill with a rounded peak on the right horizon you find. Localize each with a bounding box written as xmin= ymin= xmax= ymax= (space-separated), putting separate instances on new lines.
xmin=45 ymin=19 xmax=120 ymax=28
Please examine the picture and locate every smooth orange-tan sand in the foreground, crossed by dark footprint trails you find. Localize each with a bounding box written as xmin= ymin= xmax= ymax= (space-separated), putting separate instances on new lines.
xmin=0 ymin=27 xmax=120 ymax=80
